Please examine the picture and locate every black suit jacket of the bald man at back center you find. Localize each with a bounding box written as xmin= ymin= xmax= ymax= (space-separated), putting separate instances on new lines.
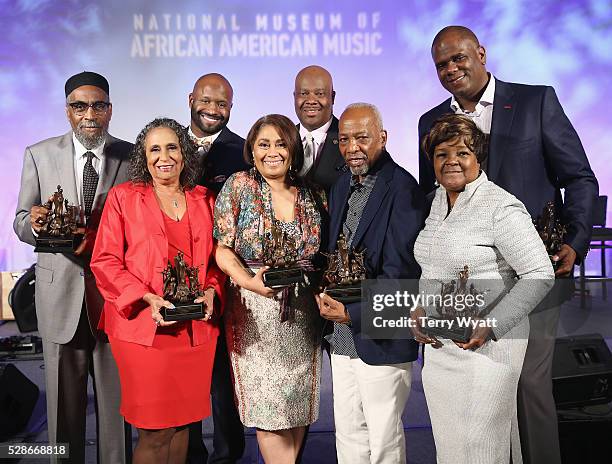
xmin=296 ymin=116 xmax=346 ymax=194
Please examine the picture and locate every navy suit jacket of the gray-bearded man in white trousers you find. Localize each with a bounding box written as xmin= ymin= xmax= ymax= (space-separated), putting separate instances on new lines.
xmin=329 ymin=152 xmax=425 ymax=365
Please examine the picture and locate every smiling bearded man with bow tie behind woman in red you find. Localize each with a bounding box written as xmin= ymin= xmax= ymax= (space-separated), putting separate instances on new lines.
xmin=188 ymin=73 xmax=250 ymax=464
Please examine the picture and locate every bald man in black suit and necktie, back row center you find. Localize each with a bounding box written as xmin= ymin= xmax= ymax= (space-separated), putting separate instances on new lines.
xmin=293 ymin=65 xmax=344 ymax=192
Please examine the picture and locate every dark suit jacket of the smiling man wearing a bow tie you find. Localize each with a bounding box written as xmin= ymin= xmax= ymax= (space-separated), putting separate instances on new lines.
xmin=198 ymin=127 xmax=251 ymax=193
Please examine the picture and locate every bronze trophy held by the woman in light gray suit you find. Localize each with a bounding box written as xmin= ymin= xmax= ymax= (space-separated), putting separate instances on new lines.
xmin=422 ymin=264 xmax=486 ymax=343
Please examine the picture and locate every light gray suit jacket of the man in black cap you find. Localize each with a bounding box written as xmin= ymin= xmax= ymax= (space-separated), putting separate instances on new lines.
xmin=13 ymin=131 xmax=132 ymax=343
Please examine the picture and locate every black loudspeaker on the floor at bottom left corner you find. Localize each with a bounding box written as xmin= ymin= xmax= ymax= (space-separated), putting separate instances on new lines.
xmin=0 ymin=364 xmax=40 ymax=441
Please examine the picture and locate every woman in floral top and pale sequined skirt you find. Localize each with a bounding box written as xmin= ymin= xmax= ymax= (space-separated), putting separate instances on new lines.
xmin=214 ymin=115 xmax=324 ymax=464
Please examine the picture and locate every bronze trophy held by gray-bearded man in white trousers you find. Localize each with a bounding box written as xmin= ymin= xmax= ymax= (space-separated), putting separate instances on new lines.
xmin=323 ymin=234 xmax=366 ymax=304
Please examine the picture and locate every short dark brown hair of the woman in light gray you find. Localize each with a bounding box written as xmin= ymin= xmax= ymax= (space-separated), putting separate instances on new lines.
xmin=422 ymin=113 xmax=488 ymax=163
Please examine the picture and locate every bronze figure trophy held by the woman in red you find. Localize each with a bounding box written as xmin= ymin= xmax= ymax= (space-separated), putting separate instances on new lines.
xmin=160 ymin=251 xmax=204 ymax=321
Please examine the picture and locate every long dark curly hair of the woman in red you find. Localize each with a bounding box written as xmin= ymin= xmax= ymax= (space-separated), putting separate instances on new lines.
xmin=129 ymin=118 xmax=201 ymax=190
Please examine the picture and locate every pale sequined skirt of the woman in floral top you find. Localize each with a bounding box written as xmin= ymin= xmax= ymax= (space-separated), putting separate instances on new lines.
xmin=225 ymin=285 xmax=322 ymax=430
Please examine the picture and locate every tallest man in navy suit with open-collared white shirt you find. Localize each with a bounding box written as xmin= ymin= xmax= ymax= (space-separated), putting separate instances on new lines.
xmin=419 ymin=26 xmax=598 ymax=464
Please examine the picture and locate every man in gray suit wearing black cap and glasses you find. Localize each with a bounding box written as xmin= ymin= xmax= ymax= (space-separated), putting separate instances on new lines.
xmin=13 ymin=72 xmax=132 ymax=464
